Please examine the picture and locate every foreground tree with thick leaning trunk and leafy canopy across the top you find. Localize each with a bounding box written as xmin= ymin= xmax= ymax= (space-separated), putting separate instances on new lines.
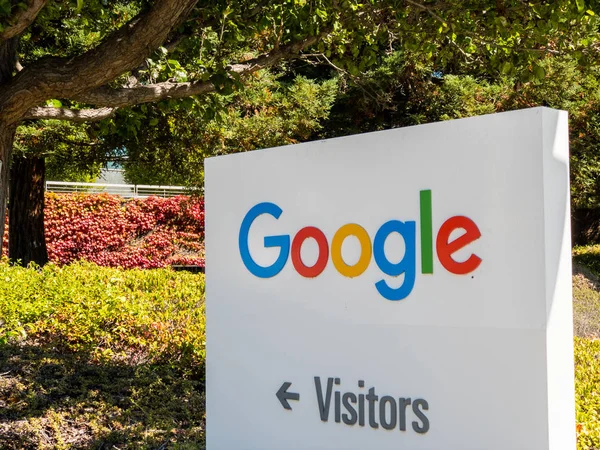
xmin=0 ymin=0 xmax=597 ymax=264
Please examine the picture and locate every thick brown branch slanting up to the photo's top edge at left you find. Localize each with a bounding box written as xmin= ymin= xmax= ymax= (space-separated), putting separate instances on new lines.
xmin=0 ymin=0 xmax=198 ymax=123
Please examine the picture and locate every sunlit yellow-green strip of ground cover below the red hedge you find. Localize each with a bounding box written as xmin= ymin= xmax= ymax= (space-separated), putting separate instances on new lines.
xmin=0 ymin=263 xmax=205 ymax=372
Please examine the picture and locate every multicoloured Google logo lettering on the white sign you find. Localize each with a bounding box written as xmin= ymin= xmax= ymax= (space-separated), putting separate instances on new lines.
xmin=239 ymin=190 xmax=481 ymax=300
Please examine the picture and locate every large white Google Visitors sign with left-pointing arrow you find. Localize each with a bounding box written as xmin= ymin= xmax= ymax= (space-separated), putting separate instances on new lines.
xmin=206 ymin=108 xmax=575 ymax=450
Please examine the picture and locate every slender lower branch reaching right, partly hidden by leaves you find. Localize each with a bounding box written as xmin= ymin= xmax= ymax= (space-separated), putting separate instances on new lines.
xmin=72 ymin=32 xmax=327 ymax=108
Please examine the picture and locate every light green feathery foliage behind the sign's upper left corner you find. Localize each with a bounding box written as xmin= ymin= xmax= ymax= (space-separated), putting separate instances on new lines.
xmin=119 ymin=71 xmax=337 ymax=187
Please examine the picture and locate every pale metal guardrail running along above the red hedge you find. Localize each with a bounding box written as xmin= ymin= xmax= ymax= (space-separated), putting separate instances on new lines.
xmin=46 ymin=181 xmax=188 ymax=198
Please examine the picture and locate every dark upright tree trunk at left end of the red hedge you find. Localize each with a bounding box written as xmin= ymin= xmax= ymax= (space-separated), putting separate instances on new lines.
xmin=8 ymin=156 xmax=48 ymax=266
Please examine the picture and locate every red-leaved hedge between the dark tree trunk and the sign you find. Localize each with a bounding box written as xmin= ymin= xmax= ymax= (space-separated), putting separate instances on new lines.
xmin=4 ymin=193 xmax=204 ymax=269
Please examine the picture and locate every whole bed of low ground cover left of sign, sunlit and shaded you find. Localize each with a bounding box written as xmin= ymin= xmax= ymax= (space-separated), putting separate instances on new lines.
xmin=0 ymin=262 xmax=205 ymax=449
